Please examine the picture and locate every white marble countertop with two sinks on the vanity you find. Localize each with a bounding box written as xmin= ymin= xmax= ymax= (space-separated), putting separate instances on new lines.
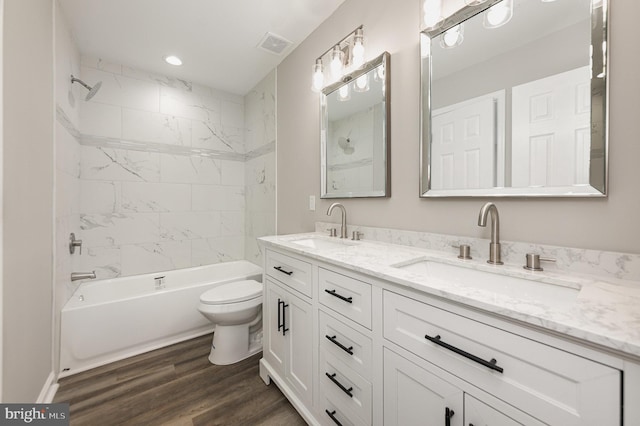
xmin=259 ymin=233 xmax=640 ymax=361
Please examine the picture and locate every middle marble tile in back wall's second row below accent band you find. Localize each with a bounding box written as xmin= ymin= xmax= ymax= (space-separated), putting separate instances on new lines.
xmin=121 ymin=182 xmax=191 ymax=212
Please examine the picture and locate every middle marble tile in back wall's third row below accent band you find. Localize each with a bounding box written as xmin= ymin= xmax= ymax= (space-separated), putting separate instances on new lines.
xmin=160 ymin=212 xmax=220 ymax=241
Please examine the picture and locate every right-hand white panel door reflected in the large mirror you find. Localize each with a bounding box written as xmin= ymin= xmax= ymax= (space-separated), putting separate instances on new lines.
xmin=512 ymin=66 xmax=591 ymax=187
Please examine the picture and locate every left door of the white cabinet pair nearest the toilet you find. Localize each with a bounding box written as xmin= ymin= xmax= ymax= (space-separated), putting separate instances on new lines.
xmin=263 ymin=279 xmax=287 ymax=375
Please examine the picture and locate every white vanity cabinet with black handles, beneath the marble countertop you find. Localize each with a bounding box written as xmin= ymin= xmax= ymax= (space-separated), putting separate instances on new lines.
xmin=260 ymin=243 xmax=640 ymax=426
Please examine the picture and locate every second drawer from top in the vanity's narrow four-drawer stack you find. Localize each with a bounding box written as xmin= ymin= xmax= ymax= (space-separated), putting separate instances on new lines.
xmin=319 ymin=311 xmax=372 ymax=378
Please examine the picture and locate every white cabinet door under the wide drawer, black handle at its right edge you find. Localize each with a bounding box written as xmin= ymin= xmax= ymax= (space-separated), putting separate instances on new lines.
xmin=383 ymin=348 xmax=463 ymax=426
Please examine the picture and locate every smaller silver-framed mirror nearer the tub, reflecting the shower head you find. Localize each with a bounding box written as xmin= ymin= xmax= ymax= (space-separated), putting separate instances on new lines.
xmin=320 ymin=52 xmax=391 ymax=198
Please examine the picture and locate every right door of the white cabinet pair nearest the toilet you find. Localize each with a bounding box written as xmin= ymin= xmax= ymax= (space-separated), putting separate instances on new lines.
xmin=283 ymin=288 xmax=313 ymax=405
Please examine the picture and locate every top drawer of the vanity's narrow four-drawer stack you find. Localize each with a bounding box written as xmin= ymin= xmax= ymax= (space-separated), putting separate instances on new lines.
xmin=318 ymin=268 xmax=371 ymax=329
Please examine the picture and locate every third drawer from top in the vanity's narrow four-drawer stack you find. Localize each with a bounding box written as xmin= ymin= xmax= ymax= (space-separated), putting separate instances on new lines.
xmin=319 ymin=351 xmax=372 ymax=424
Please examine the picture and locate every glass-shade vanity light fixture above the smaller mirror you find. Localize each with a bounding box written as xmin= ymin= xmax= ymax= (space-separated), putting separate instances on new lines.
xmin=311 ymin=25 xmax=365 ymax=92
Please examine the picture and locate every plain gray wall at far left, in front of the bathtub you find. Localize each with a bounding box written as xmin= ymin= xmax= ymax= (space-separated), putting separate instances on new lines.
xmin=2 ymin=0 xmax=53 ymax=402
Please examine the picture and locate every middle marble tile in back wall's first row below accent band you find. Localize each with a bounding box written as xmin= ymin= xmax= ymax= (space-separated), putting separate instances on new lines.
xmin=160 ymin=154 xmax=221 ymax=185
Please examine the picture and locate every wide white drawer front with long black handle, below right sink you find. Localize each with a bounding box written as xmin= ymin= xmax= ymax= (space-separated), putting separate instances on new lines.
xmin=383 ymin=291 xmax=621 ymax=425
